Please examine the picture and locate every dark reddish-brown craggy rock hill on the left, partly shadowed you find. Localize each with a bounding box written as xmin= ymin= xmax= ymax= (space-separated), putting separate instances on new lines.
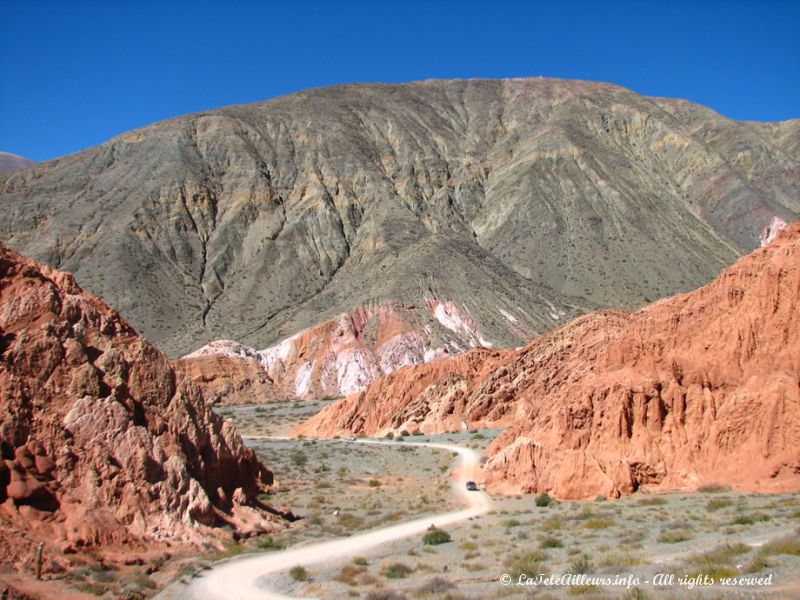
xmin=0 ymin=246 xmax=286 ymax=576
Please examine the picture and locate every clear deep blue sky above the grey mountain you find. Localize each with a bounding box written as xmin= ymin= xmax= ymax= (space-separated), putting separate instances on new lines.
xmin=0 ymin=0 xmax=800 ymax=160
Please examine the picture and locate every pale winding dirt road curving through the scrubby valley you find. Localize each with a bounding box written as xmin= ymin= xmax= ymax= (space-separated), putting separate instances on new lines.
xmin=173 ymin=440 xmax=492 ymax=600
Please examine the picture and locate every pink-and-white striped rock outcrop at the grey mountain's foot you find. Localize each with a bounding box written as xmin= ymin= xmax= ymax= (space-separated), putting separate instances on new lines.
xmin=180 ymin=301 xmax=491 ymax=404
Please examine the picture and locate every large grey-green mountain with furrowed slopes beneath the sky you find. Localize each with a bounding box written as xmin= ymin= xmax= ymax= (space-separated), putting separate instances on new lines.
xmin=0 ymin=79 xmax=800 ymax=368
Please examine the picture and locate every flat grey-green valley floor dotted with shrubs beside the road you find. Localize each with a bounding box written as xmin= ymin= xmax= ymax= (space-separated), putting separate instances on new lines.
xmin=156 ymin=403 xmax=800 ymax=600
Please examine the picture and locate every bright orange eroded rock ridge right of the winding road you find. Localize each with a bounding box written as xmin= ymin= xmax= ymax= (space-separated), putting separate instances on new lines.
xmin=296 ymin=221 xmax=800 ymax=498
